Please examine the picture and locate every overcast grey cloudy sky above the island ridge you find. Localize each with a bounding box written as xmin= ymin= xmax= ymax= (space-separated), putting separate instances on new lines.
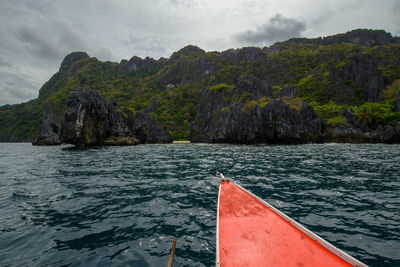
xmin=0 ymin=0 xmax=400 ymax=105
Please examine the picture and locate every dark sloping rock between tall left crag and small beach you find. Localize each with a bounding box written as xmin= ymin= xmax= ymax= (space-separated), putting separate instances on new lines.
xmin=125 ymin=109 xmax=173 ymax=144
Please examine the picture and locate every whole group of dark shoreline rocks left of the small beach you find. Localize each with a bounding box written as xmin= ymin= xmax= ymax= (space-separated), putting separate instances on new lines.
xmin=32 ymin=87 xmax=173 ymax=147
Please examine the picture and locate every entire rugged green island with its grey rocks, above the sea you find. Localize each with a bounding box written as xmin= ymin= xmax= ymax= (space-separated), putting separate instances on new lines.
xmin=0 ymin=29 xmax=400 ymax=146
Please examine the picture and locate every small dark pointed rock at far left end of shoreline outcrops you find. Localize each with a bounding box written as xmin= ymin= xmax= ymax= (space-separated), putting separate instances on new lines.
xmin=32 ymin=104 xmax=61 ymax=146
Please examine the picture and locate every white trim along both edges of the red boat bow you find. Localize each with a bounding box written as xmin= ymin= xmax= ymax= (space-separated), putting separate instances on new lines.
xmin=234 ymin=182 xmax=367 ymax=267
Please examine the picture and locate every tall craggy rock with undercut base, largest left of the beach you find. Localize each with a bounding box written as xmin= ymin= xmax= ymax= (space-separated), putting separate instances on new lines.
xmin=61 ymin=87 xmax=138 ymax=146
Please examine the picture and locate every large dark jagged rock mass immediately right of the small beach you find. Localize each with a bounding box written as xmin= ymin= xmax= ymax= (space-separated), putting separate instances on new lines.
xmin=190 ymin=75 xmax=325 ymax=144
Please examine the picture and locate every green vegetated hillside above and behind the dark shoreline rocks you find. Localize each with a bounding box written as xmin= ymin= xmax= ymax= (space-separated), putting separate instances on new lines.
xmin=0 ymin=30 xmax=400 ymax=141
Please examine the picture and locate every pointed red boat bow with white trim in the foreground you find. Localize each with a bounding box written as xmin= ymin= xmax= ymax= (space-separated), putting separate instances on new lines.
xmin=216 ymin=179 xmax=366 ymax=267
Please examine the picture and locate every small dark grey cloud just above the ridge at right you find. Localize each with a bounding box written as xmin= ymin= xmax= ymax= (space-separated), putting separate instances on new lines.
xmin=234 ymin=14 xmax=306 ymax=45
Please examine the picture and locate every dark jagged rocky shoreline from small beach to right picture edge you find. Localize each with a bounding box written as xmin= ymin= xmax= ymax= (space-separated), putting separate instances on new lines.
xmin=190 ymin=75 xmax=400 ymax=144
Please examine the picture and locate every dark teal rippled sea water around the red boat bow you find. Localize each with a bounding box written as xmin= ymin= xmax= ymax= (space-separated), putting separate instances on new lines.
xmin=0 ymin=143 xmax=400 ymax=266
